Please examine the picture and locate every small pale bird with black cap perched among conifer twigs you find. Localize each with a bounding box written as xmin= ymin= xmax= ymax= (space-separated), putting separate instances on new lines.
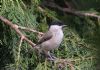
xmin=36 ymin=20 xmax=67 ymax=60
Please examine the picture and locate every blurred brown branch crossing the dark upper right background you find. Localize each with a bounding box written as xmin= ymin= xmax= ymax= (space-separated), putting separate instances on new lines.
xmin=43 ymin=2 xmax=100 ymax=19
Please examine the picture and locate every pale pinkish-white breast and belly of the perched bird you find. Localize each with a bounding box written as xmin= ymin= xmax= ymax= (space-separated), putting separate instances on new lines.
xmin=42 ymin=30 xmax=63 ymax=50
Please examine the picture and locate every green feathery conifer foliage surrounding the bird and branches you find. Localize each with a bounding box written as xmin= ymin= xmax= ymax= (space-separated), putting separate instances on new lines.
xmin=0 ymin=0 xmax=100 ymax=70
